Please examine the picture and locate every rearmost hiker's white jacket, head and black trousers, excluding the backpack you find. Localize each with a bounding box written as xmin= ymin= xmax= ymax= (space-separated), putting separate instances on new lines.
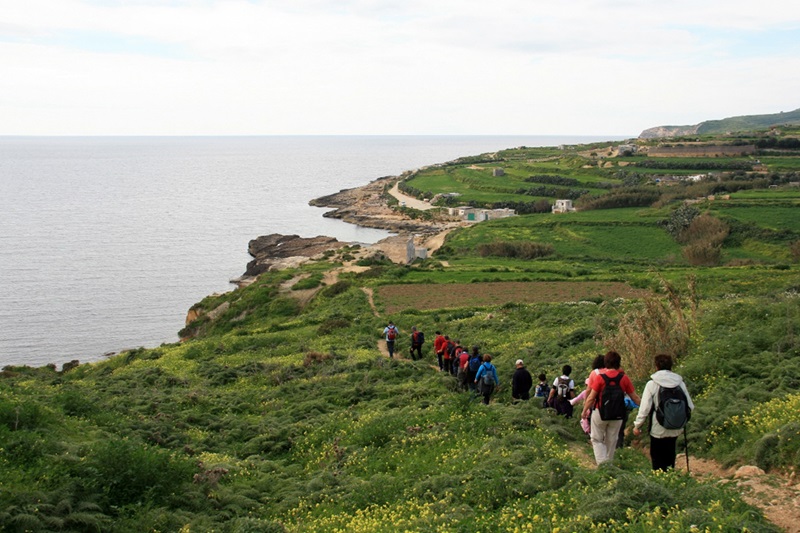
xmin=633 ymin=354 xmax=694 ymax=470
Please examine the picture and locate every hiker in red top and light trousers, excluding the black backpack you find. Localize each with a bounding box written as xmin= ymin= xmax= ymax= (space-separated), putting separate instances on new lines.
xmin=581 ymin=351 xmax=641 ymax=464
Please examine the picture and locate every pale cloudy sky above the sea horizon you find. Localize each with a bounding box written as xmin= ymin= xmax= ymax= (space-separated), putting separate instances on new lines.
xmin=0 ymin=0 xmax=800 ymax=137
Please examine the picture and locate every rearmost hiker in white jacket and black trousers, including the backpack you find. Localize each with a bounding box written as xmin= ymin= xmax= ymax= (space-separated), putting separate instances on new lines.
xmin=633 ymin=354 xmax=694 ymax=470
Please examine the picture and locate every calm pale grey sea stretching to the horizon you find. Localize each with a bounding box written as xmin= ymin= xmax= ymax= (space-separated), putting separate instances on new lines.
xmin=0 ymin=135 xmax=619 ymax=368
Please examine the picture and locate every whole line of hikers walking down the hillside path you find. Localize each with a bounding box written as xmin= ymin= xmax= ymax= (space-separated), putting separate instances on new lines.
xmin=383 ymin=322 xmax=694 ymax=470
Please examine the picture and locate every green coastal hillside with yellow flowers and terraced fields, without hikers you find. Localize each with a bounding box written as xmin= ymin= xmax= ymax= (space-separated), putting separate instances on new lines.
xmin=0 ymin=131 xmax=800 ymax=533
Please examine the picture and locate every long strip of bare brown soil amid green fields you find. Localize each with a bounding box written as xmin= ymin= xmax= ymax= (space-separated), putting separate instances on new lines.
xmin=377 ymin=281 xmax=648 ymax=313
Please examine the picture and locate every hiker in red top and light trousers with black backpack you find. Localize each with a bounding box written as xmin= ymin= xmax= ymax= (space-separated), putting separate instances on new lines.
xmin=581 ymin=350 xmax=641 ymax=465
